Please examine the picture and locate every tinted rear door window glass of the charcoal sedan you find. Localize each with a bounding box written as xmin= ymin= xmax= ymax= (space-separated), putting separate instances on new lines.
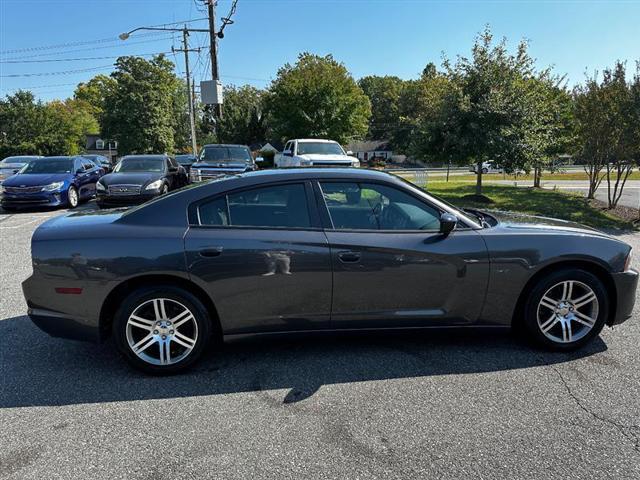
xmin=198 ymin=184 xmax=311 ymax=228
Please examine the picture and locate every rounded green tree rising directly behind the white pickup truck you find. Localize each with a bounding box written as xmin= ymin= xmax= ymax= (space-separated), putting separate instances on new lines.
xmin=266 ymin=53 xmax=371 ymax=143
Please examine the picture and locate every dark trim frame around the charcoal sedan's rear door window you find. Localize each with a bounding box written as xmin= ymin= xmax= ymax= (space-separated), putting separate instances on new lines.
xmin=187 ymin=179 xmax=324 ymax=232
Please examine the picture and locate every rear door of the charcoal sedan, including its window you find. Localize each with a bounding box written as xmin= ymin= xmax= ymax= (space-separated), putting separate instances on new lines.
xmin=185 ymin=182 xmax=332 ymax=334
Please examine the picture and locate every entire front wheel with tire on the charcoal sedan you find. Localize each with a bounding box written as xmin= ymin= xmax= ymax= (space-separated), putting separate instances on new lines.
xmin=524 ymin=269 xmax=609 ymax=351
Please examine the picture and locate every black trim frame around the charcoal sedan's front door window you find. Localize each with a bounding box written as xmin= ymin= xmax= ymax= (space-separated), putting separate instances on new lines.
xmin=313 ymin=178 xmax=473 ymax=234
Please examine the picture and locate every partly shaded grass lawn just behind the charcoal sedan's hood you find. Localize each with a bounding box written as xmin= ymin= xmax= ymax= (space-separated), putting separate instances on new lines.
xmin=420 ymin=181 xmax=635 ymax=230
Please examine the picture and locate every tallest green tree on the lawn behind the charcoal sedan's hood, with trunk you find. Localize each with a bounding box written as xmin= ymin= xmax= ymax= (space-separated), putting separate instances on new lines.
xmin=424 ymin=27 xmax=536 ymax=195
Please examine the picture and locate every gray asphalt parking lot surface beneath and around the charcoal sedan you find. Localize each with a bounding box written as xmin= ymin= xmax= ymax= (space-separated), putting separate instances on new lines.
xmin=0 ymin=203 xmax=640 ymax=479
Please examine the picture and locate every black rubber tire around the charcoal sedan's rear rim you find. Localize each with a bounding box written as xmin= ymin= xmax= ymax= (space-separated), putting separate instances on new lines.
xmin=113 ymin=285 xmax=213 ymax=375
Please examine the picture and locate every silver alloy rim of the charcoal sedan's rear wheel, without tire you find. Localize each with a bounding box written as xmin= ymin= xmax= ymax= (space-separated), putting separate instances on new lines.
xmin=126 ymin=298 xmax=198 ymax=365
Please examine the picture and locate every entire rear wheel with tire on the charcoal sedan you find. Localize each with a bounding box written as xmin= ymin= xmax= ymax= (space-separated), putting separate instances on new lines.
xmin=113 ymin=286 xmax=211 ymax=374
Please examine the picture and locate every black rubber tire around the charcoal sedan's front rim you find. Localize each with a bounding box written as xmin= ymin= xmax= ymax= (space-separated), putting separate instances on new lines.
xmin=516 ymin=268 xmax=610 ymax=351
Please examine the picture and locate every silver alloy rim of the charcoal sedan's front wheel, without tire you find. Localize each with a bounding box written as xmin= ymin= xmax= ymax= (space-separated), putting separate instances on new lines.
xmin=537 ymin=280 xmax=599 ymax=344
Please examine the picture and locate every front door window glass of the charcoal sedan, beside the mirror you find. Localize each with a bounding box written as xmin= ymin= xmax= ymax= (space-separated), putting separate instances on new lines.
xmin=320 ymin=182 xmax=440 ymax=230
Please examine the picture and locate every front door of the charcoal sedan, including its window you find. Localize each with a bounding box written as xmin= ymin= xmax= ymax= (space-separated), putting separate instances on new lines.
xmin=316 ymin=181 xmax=489 ymax=328
